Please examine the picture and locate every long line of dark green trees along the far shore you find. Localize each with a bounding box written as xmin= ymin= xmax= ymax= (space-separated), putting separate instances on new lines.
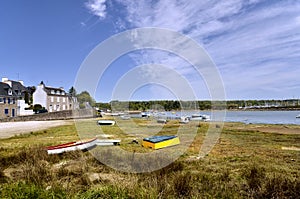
xmin=95 ymin=99 xmax=300 ymax=111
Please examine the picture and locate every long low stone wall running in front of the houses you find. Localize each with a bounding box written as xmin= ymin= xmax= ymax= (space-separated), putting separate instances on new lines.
xmin=0 ymin=109 xmax=96 ymax=122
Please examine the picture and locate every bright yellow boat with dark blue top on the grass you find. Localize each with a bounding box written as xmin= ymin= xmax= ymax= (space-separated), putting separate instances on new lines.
xmin=142 ymin=135 xmax=180 ymax=149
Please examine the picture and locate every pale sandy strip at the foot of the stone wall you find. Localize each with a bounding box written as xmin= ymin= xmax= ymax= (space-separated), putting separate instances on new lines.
xmin=0 ymin=120 xmax=72 ymax=139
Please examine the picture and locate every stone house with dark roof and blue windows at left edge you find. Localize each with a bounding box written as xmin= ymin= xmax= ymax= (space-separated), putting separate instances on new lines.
xmin=0 ymin=82 xmax=18 ymax=118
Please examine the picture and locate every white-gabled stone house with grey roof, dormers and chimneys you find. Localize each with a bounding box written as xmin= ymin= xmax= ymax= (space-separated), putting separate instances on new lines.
xmin=33 ymin=81 xmax=78 ymax=112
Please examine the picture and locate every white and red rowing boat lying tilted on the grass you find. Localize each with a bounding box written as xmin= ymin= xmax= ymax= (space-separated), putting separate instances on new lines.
xmin=46 ymin=138 xmax=97 ymax=154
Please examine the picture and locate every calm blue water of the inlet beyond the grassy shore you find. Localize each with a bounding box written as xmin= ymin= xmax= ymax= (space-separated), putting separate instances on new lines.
xmin=140 ymin=111 xmax=300 ymax=125
